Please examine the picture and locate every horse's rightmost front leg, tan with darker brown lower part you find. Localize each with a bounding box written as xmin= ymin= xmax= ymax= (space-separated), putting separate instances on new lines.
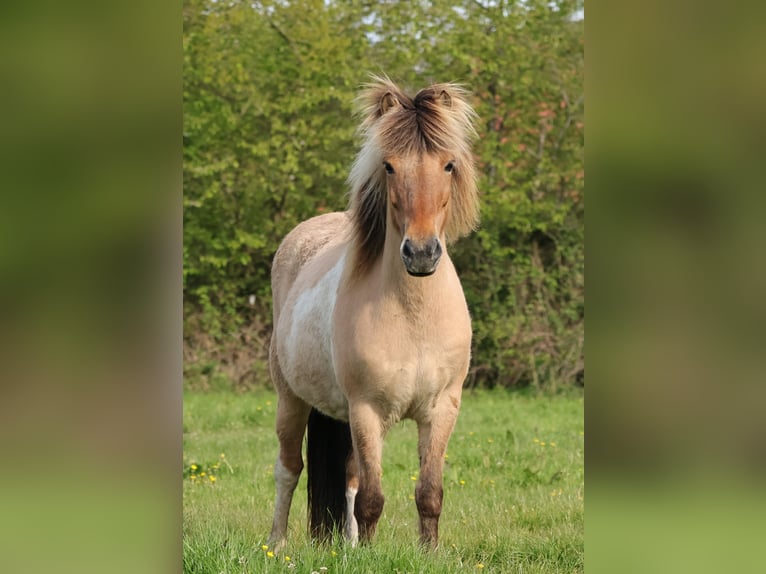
xmin=415 ymin=396 xmax=460 ymax=548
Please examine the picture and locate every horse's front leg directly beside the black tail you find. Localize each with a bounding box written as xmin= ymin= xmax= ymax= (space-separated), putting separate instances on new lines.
xmin=349 ymin=403 xmax=385 ymax=542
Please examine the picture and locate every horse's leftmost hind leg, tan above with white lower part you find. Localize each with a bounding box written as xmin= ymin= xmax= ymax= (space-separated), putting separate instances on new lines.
xmin=269 ymin=385 xmax=311 ymax=551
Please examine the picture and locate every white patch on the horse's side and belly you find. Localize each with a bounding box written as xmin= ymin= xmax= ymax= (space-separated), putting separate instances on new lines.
xmin=277 ymin=254 xmax=348 ymax=420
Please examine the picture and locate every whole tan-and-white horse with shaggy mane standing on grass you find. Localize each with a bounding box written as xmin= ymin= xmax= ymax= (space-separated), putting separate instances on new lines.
xmin=269 ymin=76 xmax=479 ymax=550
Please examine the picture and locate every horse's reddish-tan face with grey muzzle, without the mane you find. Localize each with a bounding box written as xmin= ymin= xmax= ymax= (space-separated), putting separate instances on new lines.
xmin=383 ymin=153 xmax=455 ymax=277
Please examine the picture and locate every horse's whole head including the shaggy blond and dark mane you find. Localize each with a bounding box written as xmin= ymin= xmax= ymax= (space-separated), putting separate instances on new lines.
xmin=349 ymin=78 xmax=479 ymax=277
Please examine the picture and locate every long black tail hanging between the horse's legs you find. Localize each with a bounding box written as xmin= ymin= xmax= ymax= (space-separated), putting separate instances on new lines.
xmin=306 ymin=409 xmax=351 ymax=540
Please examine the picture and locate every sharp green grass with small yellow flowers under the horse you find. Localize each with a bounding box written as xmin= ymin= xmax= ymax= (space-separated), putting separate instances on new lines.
xmin=183 ymin=390 xmax=584 ymax=574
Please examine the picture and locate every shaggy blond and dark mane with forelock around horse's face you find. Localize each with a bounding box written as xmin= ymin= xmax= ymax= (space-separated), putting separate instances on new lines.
xmin=348 ymin=76 xmax=479 ymax=271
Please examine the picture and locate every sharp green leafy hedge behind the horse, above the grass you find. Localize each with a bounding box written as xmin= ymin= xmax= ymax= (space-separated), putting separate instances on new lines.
xmin=183 ymin=0 xmax=584 ymax=387
